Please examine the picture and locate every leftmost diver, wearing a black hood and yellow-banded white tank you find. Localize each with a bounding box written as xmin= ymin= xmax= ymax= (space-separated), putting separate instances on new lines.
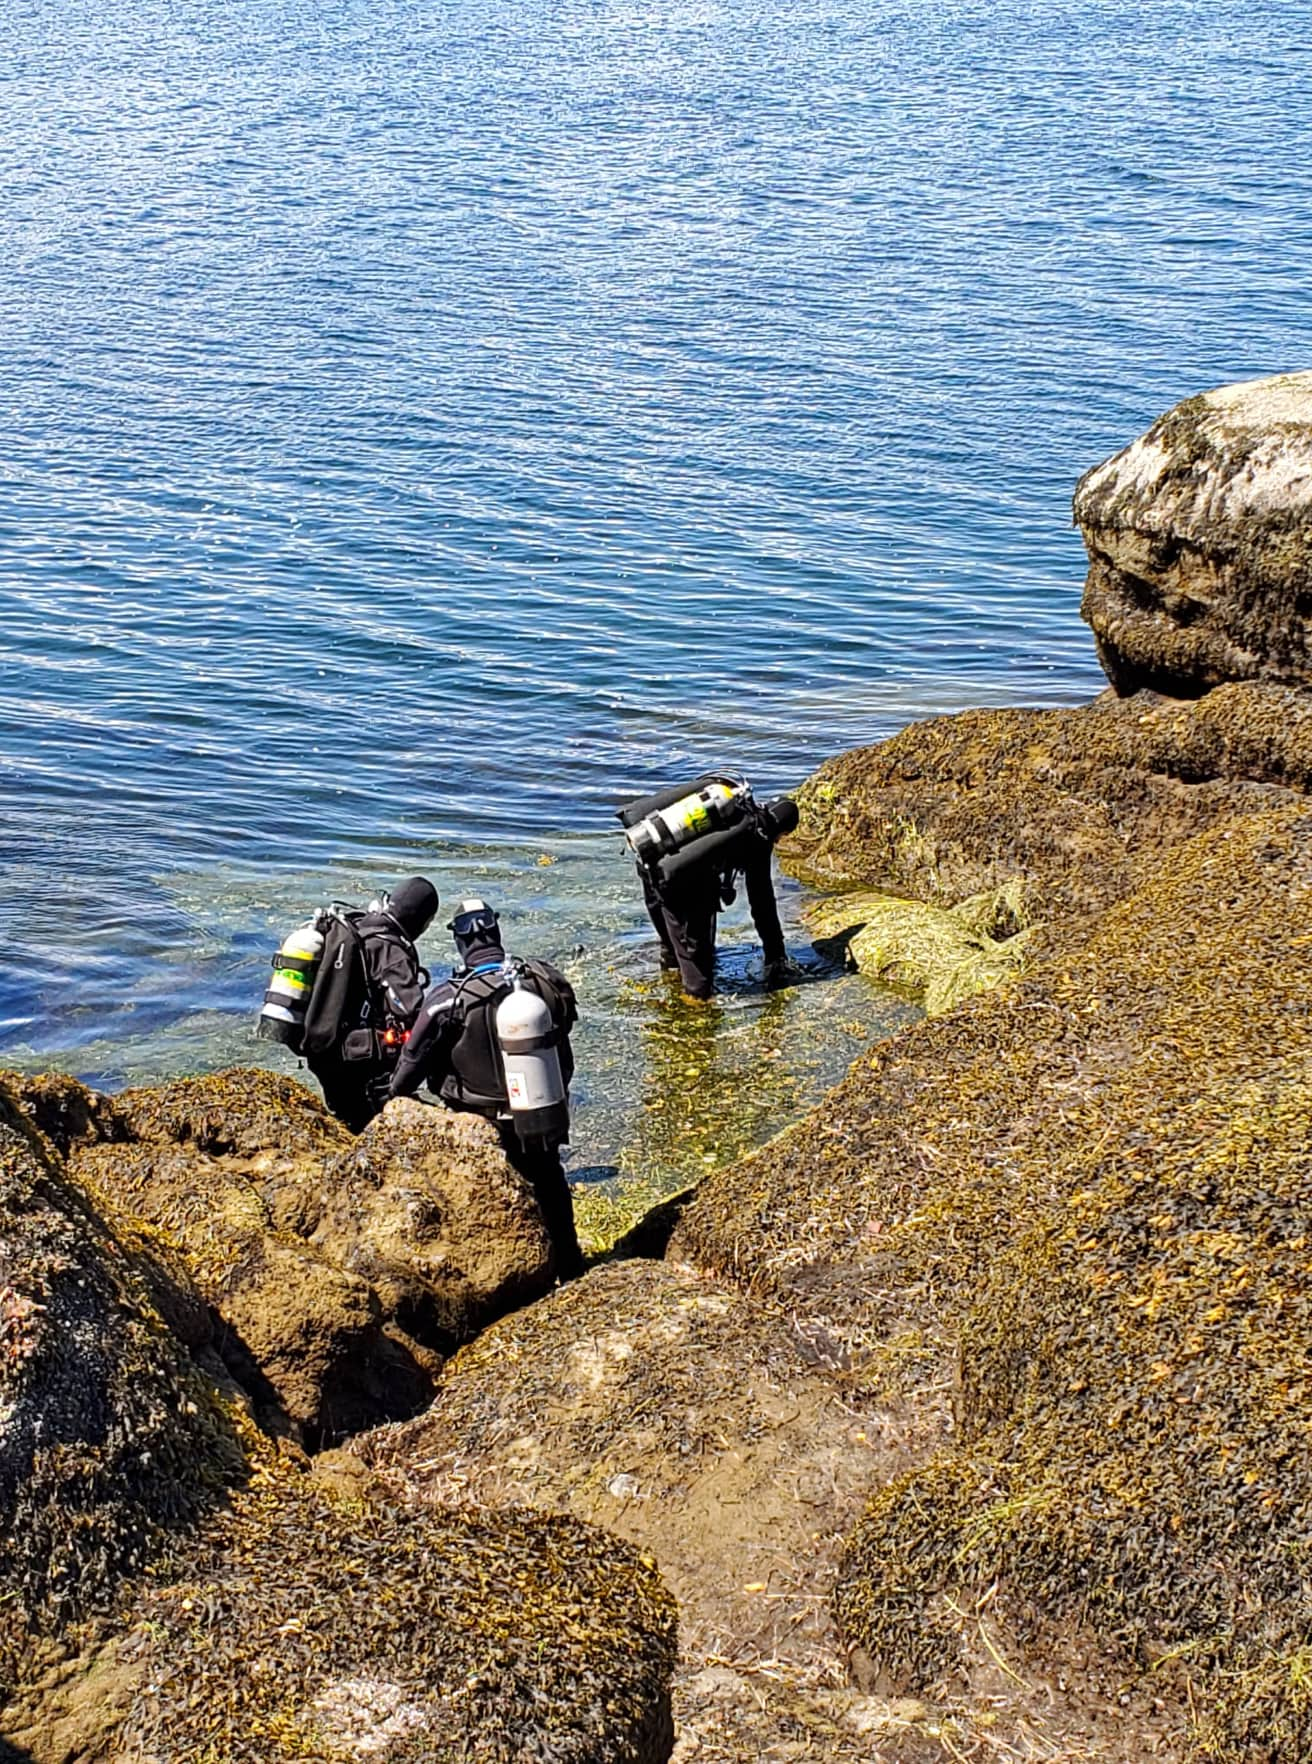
xmin=257 ymin=877 xmax=437 ymax=1132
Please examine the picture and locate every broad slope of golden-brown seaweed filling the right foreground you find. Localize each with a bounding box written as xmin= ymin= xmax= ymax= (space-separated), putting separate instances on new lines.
xmin=672 ymin=804 xmax=1312 ymax=1764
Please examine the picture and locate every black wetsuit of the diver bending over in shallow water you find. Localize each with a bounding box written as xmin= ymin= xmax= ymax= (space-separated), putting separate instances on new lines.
xmin=638 ymin=817 xmax=786 ymax=998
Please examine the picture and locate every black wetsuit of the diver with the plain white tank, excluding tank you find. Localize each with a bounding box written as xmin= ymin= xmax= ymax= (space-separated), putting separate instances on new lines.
xmin=391 ymin=944 xmax=584 ymax=1281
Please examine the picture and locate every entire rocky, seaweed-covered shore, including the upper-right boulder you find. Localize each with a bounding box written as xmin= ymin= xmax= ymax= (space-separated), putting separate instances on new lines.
xmin=0 ymin=374 xmax=1312 ymax=1764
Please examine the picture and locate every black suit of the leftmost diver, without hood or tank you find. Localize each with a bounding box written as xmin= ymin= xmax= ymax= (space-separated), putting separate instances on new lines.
xmin=303 ymin=912 xmax=429 ymax=1132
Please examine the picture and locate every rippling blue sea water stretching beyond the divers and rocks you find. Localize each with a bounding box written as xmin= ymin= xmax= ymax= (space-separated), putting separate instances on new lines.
xmin=0 ymin=0 xmax=1312 ymax=1157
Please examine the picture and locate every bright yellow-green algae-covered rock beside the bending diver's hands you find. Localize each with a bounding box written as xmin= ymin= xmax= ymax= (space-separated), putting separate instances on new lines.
xmin=806 ymin=882 xmax=1028 ymax=1016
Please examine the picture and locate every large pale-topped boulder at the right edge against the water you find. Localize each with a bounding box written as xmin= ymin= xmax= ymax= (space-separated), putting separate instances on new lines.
xmin=1074 ymin=372 xmax=1312 ymax=697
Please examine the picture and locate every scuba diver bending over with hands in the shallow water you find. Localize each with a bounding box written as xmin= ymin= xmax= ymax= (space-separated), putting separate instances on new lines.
xmin=617 ymin=773 xmax=797 ymax=1000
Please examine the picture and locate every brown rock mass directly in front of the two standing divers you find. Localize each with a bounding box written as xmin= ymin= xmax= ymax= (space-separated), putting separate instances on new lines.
xmin=30 ymin=1069 xmax=552 ymax=1446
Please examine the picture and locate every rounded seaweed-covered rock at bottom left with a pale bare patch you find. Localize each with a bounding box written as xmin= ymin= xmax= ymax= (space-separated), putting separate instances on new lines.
xmin=122 ymin=1478 xmax=675 ymax=1764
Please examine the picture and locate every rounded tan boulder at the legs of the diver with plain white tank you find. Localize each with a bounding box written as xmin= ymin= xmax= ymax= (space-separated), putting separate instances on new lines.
xmin=312 ymin=1097 xmax=552 ymax=1351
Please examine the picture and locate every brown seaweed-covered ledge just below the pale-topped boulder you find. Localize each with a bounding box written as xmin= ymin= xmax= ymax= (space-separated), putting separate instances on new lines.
xmin=783 ymin=686 xmax=1312 ymax=924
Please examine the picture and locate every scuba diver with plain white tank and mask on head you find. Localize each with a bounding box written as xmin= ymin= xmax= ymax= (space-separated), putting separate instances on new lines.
xmin=382 ymin=900 xmax=584 ymax=1281
